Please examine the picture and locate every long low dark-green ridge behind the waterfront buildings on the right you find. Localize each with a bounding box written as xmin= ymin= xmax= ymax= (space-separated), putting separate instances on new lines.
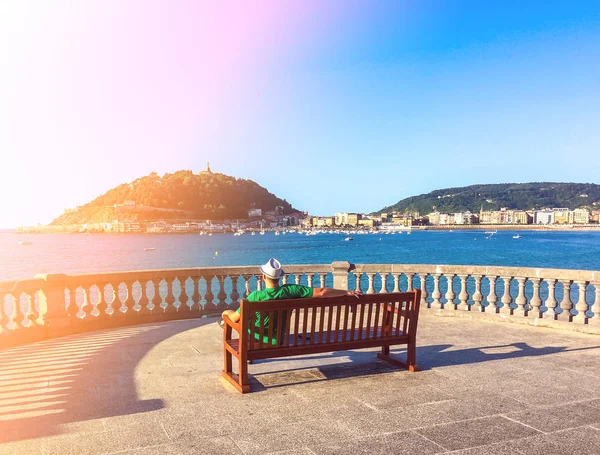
xmin=373 ymin=182 xmax=600 ymax=215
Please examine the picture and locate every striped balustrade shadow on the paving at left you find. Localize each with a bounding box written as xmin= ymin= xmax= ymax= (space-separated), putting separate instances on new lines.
xmin=0 ymin=319 xmax=212 ymax=443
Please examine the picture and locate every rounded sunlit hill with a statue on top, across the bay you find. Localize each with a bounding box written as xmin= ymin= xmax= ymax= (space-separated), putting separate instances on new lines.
xmin=51 ymin=171 xmax=295 ymax=225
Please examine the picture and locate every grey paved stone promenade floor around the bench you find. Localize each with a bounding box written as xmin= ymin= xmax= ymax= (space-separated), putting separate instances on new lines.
xmin=0 ymin=313 xmax=600 ymax=455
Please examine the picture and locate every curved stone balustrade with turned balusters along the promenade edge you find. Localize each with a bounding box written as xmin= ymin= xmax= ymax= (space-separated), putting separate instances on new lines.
xmin=0 ymin=262 xmax=600 ymax=348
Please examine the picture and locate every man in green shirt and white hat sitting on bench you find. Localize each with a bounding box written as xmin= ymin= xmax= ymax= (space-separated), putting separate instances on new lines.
xmin=223 ymin=258 xmax=361 ymax=343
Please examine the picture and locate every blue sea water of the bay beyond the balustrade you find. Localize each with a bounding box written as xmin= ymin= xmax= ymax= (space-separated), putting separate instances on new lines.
xmin=0 ymin=230 xmax=600 ymax=281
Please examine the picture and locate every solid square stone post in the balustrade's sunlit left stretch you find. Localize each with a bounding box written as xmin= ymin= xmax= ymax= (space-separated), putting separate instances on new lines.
xmin=36 ymin=274 xmax=74 ymax=337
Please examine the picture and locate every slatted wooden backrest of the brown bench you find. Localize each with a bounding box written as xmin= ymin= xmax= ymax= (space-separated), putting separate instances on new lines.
xmin=240 ymin=289 xmax=421 ymax=350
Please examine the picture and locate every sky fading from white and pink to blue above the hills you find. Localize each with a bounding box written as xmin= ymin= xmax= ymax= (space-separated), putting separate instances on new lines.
xmin=0 ymin=0 xmax=600 ymax=228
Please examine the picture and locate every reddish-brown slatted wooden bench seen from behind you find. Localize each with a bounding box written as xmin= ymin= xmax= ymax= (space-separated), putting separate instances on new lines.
xmin=222 ymin=289 xmax=421 ymax=393
